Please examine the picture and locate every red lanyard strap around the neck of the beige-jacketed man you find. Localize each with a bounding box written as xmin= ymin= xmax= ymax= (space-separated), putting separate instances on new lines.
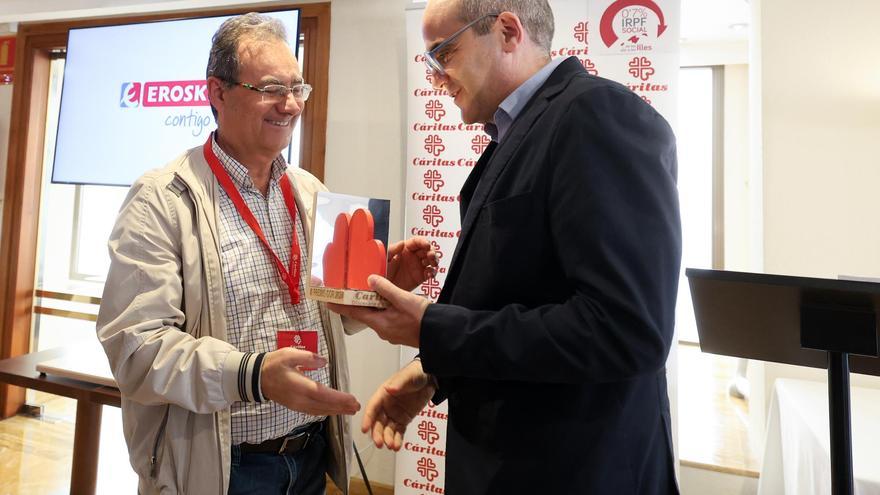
xmin=204 ymin=133 xmax=300 ymax=305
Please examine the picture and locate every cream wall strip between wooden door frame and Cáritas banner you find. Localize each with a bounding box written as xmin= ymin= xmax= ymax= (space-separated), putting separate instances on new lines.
xmin=324 ymin=0 xmax=406 ymax=484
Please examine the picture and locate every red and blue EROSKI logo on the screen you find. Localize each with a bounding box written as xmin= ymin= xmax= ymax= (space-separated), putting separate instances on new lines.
xmin=119 ymin=80 xmax=208 ymax=108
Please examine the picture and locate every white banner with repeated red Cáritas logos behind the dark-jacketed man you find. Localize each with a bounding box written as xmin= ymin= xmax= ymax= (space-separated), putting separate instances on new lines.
xmin=394 ymin=0 xmax=680 ymax=495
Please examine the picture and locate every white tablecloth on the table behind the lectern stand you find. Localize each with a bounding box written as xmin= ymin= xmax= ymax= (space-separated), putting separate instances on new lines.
xmin=758 ymin=379 xmax=880 ymax=495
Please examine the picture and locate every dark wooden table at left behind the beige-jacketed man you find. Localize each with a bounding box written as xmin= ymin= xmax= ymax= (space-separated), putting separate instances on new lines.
xmin=0 ymin=348 xmax=121 ymax=494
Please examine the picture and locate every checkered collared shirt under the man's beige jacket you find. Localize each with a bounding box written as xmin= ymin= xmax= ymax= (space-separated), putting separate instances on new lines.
xmin=212 ymin=140 xmax=330 ymax=445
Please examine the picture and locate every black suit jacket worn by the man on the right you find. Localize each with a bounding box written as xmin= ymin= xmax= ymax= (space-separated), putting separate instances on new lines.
xmin=420 ymin=58 xmax=681 ymax=495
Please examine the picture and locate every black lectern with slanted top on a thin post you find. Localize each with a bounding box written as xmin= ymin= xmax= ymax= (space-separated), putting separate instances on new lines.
xmin=685 ymin=268 xmax=880 ymax=495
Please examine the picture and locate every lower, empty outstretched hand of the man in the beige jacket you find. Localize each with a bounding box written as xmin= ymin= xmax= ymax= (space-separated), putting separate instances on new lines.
xmin=260 ymin=347 xmax=361 ymax=416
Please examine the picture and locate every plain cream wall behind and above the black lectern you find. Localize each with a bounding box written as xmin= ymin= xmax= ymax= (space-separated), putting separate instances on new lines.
xmin=757 ymin=0 xmax=880 ymax=458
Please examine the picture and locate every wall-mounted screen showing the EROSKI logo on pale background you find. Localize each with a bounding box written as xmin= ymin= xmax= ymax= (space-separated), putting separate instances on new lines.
xmin=52 ymin=10 xmax=299 ymax=186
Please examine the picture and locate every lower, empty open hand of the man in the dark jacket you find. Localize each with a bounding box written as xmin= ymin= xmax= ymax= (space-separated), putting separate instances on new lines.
xmin=361 ymin=359 xmax=435 ymax=452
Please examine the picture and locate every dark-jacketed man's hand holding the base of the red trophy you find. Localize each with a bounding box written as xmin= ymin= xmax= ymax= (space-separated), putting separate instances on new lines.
xmin=327 ymin=275 xmax=428 ymax=348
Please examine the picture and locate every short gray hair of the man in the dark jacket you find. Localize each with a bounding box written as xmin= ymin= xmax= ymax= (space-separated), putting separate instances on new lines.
xmin=458 ymin=0 xmax=553 ymax=53
